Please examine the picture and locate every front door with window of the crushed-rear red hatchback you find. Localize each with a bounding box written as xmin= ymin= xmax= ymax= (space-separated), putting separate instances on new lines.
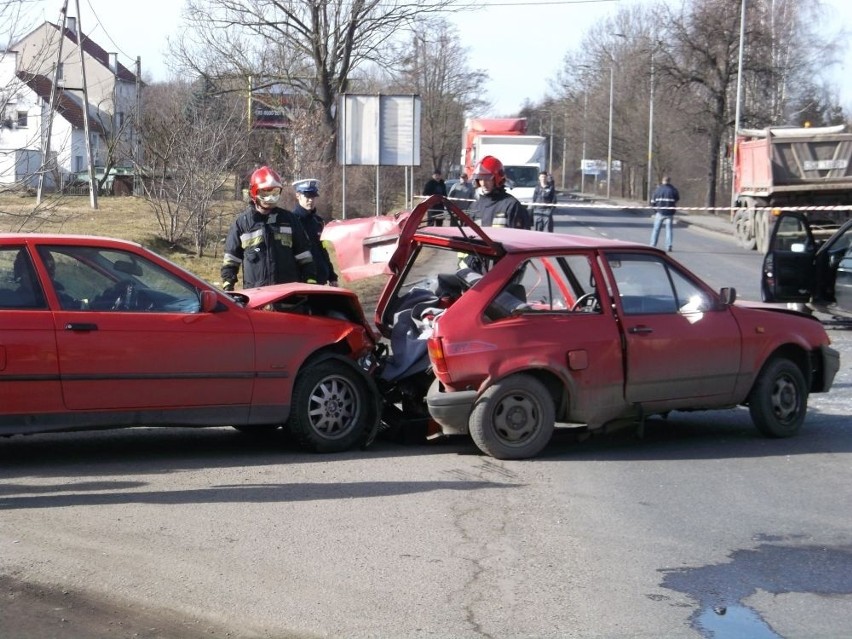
xmin=605 ymin=252 xmax=742 ymax=404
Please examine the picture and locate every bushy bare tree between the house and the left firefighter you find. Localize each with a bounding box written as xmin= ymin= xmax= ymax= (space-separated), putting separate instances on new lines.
xmin=140 ymin=82 xmax=246 ymax=257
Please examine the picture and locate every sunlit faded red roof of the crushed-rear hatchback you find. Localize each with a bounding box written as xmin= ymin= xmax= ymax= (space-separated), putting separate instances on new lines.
xmin=416 ymin=226 xmax=649 ymax=253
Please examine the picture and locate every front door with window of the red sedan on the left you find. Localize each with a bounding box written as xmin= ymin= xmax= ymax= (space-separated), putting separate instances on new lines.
xmin=43 ymin=246 xmax=255 ymax=410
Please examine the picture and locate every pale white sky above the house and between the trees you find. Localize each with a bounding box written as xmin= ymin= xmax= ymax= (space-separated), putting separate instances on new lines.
xmin=18 ymin=0 xmax=852 ymax=117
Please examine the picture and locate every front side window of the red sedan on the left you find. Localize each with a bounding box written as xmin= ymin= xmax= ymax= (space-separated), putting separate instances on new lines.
xmin=39 ymin=246 xmax=201 ymax=313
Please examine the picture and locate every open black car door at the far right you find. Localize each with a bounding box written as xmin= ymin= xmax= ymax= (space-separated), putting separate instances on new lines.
xmin=760 ymin=211 xmax=817 ymax=302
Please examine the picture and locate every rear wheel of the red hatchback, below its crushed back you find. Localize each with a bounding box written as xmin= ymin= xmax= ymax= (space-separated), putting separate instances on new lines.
xmin=469 ymin=374 xmax=555 ymax=459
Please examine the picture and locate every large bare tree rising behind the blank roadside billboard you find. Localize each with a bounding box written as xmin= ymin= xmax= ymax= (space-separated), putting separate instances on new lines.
xmin=178 ymin=0 xmax=460 ymax=165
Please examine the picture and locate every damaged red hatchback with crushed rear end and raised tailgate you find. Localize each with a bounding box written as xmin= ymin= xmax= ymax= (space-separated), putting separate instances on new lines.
xmin=328 ymin=196 xmax=839 ymax=459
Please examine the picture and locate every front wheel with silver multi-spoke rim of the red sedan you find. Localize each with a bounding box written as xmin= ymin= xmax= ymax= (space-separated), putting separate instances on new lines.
xmin=287 ymin=359 xmax=378 ymax=453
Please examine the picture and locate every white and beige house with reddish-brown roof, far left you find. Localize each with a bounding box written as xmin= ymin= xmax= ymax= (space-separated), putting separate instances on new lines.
xmin=0 ymin=17 xmax=142 ymax=187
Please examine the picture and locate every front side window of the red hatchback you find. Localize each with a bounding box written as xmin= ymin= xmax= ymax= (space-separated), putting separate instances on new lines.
xmin=607 ymin=253 xmax=712 ymax=315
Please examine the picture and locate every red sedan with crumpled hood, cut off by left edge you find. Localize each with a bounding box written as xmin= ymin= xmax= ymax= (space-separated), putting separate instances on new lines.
xmin=0 ymin=234 xmax=380 ymax=452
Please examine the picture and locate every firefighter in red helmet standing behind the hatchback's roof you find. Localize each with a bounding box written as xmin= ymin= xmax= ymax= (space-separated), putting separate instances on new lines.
xmin=467 ymin=155 xmax=531 ymax=229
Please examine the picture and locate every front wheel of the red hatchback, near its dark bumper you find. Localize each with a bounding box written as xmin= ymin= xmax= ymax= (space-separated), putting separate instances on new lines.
xmin=748 ymin=357 xmax=808 ymax=437
